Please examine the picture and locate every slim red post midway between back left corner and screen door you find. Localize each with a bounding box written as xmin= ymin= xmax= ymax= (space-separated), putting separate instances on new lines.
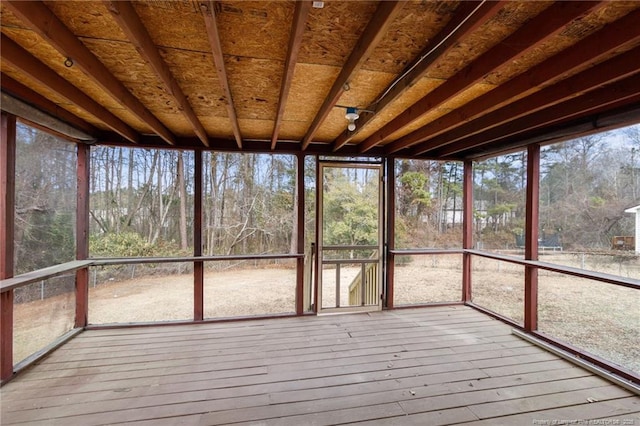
xmin=193 ymin=151 xmax=204 ymax=321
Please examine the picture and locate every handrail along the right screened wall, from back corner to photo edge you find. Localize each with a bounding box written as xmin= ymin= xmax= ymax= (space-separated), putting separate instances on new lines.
xmin=463 ymin=249 xmax=640 ymax=290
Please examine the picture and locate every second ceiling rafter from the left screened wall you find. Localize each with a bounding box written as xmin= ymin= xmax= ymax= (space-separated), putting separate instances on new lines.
xmin=0 ymin=34 xmax=140 ymax=143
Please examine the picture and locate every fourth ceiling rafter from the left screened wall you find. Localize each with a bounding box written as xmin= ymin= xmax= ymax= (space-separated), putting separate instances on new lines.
xmin=106 ymin=1 xmax=209 ymax=146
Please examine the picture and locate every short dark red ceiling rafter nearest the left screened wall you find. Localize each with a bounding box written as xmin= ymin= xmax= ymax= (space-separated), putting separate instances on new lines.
xmin=0 ymin=73 xmax=98 ymax=136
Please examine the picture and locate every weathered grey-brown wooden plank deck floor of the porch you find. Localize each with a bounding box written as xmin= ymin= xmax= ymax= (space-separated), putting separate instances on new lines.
xmin=1 ymin=306 xmax=640 ymax=426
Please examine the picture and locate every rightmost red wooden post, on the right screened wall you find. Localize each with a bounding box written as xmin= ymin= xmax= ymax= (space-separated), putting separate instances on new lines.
xmin=524 ymin=145 xmax=540 ymax=331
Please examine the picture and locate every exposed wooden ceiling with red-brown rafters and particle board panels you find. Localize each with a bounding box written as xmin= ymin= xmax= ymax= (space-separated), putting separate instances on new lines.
xmin=0 ymin=0 xmax=640 ymax=158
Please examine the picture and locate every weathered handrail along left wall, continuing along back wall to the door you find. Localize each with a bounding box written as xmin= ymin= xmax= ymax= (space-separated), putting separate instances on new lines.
xmin=0 ymin=254 xmax=304 ymax=293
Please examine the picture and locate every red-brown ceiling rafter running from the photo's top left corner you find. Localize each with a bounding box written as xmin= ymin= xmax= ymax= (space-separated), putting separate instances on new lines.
xmin=3 ymin=0 xmax=175 ymax=144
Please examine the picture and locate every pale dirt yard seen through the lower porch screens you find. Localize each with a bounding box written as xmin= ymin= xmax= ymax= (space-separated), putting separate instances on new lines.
xmin=14 ymin=255 xmax=640 ymax=372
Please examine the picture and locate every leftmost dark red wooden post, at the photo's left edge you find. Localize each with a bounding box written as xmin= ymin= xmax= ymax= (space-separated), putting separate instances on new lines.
xmin=0 ymin=112 xmax=16 ymax=381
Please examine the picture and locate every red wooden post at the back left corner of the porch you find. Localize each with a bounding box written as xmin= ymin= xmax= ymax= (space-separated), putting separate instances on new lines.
xmin=75 ymin=144 xmax=91 ymax=327
